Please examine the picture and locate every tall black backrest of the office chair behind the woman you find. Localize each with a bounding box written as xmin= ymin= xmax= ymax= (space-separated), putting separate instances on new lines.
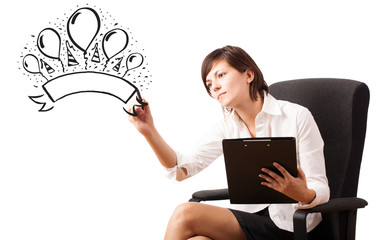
xmin=270 ymin=78 xmax=369 ymax=239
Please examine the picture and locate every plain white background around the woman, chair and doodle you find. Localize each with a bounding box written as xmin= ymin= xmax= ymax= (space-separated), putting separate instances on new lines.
xmin=0 ymin=0 xmax=377 ymax=240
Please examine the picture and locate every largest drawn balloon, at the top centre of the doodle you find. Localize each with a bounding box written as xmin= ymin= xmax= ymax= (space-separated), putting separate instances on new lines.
xmin=67 ymin=7 xmax=101 ymax=52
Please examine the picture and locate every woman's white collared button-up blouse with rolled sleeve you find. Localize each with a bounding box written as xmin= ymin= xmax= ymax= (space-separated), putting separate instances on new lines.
xmin=166 ymin=93 xmax=330 ymax=232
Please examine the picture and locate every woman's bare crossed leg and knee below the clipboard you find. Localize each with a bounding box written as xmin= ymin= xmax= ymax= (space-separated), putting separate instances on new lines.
xmin=165 ymin=203 xmax=246 ymax=240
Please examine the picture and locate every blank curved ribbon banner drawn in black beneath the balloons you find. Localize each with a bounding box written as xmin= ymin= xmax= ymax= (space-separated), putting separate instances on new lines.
xmin=29 ymin=72 xmax=146 ymax=116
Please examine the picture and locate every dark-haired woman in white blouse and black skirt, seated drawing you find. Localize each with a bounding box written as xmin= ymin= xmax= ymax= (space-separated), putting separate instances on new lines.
xmin=129 ymin=46 xmax=330 ymax=240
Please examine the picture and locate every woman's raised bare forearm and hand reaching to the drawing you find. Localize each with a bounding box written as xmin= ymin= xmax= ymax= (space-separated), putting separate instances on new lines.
xmin=129 ymin=99 xmax=177 ymax=168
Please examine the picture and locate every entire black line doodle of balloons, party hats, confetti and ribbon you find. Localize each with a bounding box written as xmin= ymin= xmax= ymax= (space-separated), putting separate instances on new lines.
xmin=20 ymin=4 xmax=151 ymax=116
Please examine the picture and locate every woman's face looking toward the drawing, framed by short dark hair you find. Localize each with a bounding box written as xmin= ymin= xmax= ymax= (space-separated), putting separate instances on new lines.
xmin=206 ymin=60 xmax=254 ymax=109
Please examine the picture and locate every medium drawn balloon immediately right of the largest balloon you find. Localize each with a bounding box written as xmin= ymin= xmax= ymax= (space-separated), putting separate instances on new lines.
xmin=102 ymin=28 xmax=128 ymax=59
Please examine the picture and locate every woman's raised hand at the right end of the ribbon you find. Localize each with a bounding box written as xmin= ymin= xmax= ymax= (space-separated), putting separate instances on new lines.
xmin=128 ymin=99 xmax=154 ymax=136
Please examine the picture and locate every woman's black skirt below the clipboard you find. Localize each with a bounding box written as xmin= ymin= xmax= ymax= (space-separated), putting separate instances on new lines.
xmin=229 ymin=208 xmax=294 ymax=240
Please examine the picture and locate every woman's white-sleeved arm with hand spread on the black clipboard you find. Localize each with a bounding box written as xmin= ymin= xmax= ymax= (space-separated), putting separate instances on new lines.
xmin=260 ymin=109 xmax=330 ymax=207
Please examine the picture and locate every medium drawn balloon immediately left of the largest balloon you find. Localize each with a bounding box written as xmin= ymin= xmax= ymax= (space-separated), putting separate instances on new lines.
xmin=37 ymin=28 xmax=60 ymax=59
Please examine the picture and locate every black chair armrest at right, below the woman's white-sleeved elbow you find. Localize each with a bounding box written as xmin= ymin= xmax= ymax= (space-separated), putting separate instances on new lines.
xmin=293 ymin=197 xmax=368 ymax=240
